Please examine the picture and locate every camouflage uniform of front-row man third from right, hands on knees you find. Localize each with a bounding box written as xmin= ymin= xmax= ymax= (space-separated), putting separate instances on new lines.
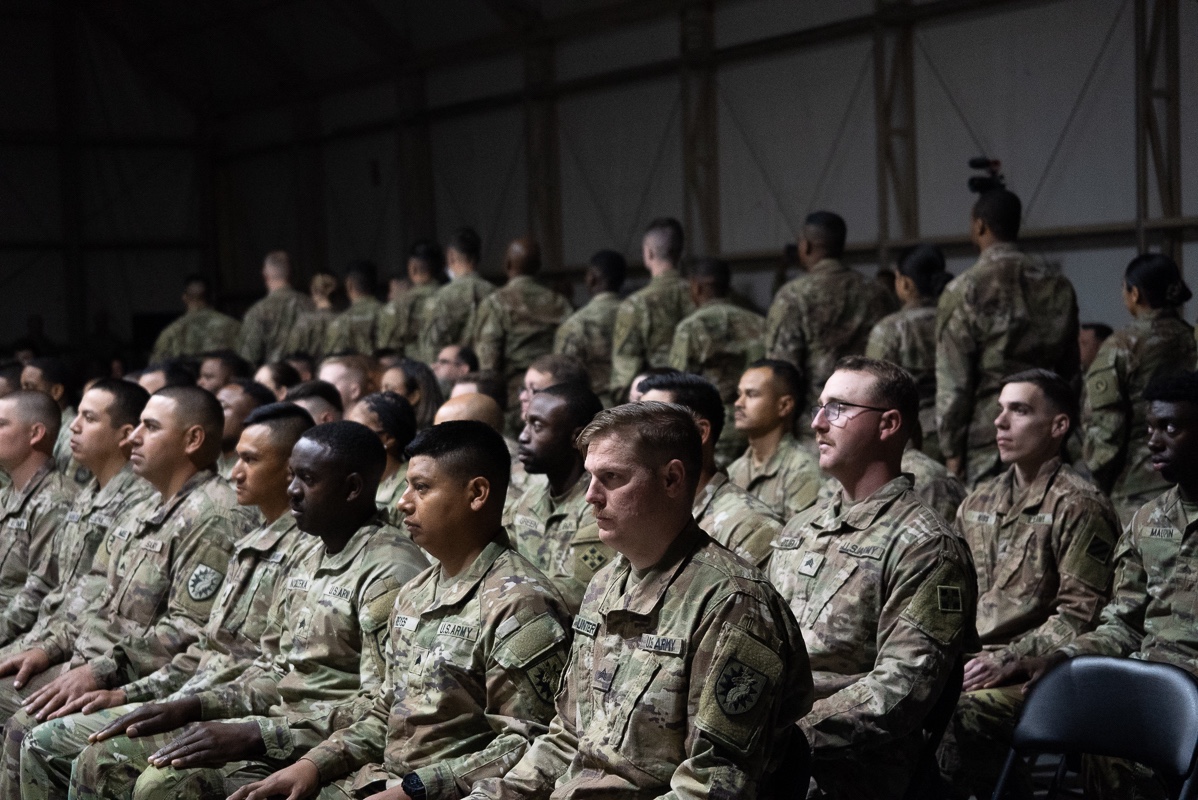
xmin=72 ymin=520 xmax=428 ymax=800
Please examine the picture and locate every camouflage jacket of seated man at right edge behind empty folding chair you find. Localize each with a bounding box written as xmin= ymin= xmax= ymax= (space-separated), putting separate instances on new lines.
xmin=1060 ymin=486 xmax=1198 ymax=675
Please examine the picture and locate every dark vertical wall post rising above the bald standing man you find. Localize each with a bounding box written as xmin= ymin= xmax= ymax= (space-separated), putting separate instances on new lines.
xmin=525 ymin=41 xmax=565 ymax=271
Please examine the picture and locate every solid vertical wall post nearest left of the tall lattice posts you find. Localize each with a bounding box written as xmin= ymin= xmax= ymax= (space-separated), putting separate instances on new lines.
xmin=680 ymin=0 xmax=720 ymax=256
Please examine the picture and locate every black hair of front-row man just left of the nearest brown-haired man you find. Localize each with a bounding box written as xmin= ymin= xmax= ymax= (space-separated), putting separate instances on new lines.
xmin=407 ymin=419 xmax=512 ymax=504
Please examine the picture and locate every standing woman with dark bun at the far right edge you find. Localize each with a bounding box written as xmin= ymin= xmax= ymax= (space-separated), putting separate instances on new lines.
xmin=1082 ymin=253 xmax=1196 ymax=525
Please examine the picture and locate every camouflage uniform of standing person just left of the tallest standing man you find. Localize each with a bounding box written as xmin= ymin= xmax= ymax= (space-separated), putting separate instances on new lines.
xmin=865 ymin=302 xmax=952 ymax=459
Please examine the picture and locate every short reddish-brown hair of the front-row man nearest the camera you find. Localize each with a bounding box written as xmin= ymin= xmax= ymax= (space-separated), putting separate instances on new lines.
xmin=577 ymin=402 xmax=703 ymax=495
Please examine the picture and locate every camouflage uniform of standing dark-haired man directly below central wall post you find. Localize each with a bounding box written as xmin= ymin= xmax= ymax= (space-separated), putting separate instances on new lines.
xmin=670 ymin=298 xmax=766 ymax=466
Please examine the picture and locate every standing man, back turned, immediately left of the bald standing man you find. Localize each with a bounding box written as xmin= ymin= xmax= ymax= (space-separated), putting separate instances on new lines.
xmin=420 ymin=228 xmax=495 ymax=353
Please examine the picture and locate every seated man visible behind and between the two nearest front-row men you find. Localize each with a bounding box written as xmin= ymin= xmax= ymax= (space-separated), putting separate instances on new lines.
xmin=508 ymin=383 xmax=613 ymax=612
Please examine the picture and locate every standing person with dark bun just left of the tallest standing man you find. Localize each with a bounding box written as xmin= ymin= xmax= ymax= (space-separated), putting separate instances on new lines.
xmin=865 ymin=244 xmax=952 ymax=459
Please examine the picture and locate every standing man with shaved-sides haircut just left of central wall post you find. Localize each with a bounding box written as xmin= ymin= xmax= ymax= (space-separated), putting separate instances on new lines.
xmin=609 ymin=217 xmax=695 ymax=402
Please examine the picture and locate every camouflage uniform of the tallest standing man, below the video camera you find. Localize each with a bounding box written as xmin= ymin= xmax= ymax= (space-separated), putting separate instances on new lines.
xmin=936 ymin=243 xmax=1079 ymax=486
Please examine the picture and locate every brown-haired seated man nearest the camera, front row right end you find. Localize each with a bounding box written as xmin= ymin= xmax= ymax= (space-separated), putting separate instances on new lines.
xmin=471 ymin=402 xmax=811 ymax=800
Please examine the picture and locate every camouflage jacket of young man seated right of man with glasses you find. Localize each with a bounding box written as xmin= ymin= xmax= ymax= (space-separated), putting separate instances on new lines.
xmin=957 ymin=459 xmax=1119 ymax=663
